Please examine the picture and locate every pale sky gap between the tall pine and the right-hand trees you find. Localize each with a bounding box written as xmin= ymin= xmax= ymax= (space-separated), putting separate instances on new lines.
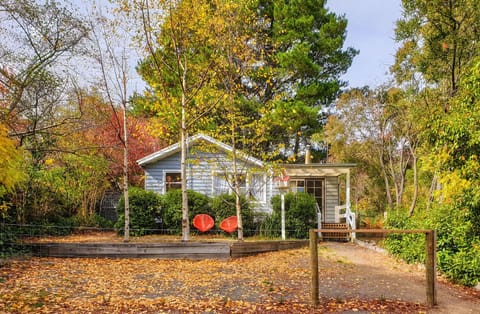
xmin=327 ymin=0 xmax=401 ymax=87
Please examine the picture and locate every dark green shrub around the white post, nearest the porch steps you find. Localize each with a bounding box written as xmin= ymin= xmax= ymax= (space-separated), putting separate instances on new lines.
xmin=261 ymin=193 xmax=317 ymax=239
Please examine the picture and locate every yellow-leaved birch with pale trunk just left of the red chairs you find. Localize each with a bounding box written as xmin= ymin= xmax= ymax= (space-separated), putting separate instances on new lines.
xmin=120 ymin=0 xmax=227 ymax=241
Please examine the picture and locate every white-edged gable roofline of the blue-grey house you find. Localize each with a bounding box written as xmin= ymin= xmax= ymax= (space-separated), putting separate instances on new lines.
xmin=137 ymin=133 xmax=263 ymax=167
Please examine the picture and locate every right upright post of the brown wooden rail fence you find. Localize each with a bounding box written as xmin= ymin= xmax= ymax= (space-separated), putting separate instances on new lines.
xmin=425 ymin=230 xmax=437 ymax=306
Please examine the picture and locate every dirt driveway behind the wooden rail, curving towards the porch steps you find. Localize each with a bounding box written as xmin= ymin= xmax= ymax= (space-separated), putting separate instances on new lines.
xmin=320 ymin=242 xmax=480 ymax=314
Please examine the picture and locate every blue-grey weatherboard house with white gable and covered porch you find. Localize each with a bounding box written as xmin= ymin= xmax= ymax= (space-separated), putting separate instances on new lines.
xmin=137 ymin=134 xmax=355 ymax=232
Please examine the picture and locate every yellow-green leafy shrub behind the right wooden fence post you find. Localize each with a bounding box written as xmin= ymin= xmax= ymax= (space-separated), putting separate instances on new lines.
xmin=385 ymin=201 xmax=480 ymax=286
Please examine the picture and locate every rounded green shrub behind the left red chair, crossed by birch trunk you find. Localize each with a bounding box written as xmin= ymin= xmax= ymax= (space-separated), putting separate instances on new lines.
xmin=161 ymin=189 xmax=213 ymax=233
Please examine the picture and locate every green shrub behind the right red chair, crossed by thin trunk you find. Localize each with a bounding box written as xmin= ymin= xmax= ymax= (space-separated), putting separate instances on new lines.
xmin=212 ymin=194 xmax=256 ymax=236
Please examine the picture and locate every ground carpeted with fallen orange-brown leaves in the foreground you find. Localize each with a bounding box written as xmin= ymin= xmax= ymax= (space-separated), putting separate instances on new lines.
xmin=0 ymin=248 xmax=427 ymax=313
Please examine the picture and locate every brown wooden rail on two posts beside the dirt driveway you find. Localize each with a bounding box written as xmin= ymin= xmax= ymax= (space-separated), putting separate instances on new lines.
xmin=309 ymin=229 xmax=437 ymax=306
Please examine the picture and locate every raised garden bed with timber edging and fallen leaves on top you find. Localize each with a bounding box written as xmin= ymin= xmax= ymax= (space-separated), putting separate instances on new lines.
xmin=24 ymin=233 xmax=308 ymax=259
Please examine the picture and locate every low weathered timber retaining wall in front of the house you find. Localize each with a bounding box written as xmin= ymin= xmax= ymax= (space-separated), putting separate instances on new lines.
xmin=28 ymin=240 xmax=308 ymax=259
